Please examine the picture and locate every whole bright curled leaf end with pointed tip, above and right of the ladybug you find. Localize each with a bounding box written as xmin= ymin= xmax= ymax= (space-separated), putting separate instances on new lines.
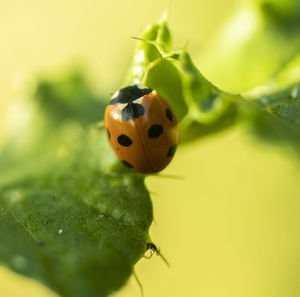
xmin=128 ymin=15 xmax=236 ymax=130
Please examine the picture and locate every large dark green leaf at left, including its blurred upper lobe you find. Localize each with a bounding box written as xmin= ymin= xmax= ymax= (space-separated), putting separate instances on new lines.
xmin=0 ymin=72 xmax=152 ymax=297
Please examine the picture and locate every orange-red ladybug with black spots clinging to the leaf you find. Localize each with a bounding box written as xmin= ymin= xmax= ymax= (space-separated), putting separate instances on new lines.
xmin=104 ymin=85 xmax=178 ymax=173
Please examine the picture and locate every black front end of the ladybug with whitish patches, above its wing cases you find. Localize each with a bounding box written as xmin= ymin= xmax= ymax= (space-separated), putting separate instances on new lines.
xmin=109 ymin=85 xmax=152 ymax=105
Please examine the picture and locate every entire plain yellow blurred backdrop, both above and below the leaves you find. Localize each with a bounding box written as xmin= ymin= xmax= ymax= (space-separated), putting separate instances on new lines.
xmin=0 ymin=0 xmax=300 ymax=297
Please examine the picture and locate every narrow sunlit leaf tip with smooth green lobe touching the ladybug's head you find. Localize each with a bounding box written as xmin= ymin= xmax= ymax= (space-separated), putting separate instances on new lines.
xmin=124 ymin=14 xmax=187 ymax=120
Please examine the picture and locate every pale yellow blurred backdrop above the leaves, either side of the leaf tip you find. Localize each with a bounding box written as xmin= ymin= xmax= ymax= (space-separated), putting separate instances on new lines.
xmin=0 ymin=0 xmax=239 ymax=143
